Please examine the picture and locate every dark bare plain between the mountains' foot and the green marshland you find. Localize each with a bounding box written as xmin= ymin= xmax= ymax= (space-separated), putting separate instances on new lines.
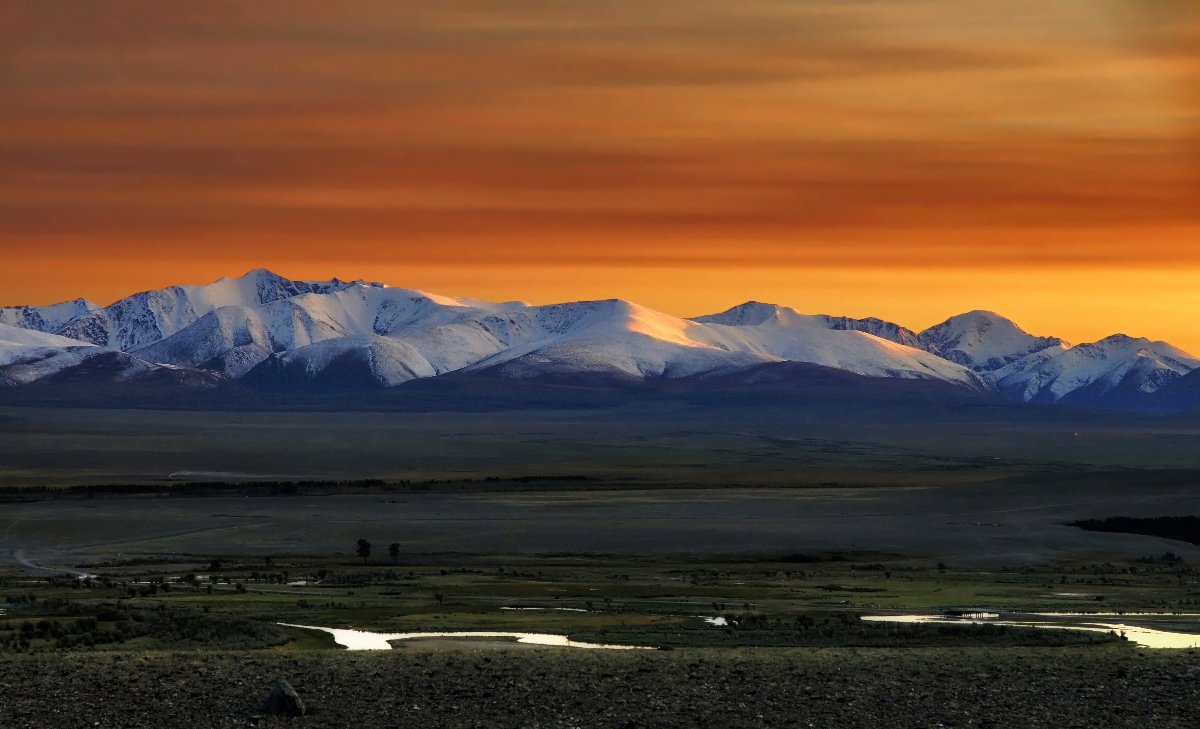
xmin=0 ymin=403 xmax=1200 ymax=564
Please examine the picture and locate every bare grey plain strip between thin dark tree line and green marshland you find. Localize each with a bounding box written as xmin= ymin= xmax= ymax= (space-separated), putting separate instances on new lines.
xmin=0 ymin=471 xmax=1200 ymax=565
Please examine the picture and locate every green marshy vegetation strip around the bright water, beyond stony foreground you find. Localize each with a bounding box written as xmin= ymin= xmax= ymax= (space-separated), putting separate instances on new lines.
xmin=0 ymin=553 xmax=1200 ymax=651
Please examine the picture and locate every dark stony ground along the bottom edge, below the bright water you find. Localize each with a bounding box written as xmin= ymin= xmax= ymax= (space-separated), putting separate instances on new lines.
xmin=0 ymin=646 xmax=1200 ymax=729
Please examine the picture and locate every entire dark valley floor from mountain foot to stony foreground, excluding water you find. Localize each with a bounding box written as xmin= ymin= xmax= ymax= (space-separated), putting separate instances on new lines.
xmin=7 ymin=409 xmax=1200 ymax=729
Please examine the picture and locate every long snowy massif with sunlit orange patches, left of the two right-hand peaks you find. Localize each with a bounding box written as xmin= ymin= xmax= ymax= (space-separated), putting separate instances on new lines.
xmin=0 ymin=278 xmax=1012 ymax=388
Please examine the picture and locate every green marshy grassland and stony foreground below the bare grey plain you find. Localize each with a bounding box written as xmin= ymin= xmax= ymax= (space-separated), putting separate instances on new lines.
xmin=0 ymin=554 xmax=1200 ymax=728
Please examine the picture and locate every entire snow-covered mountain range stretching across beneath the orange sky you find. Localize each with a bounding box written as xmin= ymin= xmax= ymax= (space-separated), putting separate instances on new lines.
xmin=0 ymin=270 xmax=1200 ymax=410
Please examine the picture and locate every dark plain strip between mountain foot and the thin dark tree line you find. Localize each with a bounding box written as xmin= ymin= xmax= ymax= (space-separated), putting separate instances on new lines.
xmin=0 ymin=403 xmax=1200 ymax=487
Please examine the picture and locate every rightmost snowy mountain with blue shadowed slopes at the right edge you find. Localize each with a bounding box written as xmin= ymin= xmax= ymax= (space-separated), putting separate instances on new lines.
xmin=997 ymin=335 xmax=1200 ymax=403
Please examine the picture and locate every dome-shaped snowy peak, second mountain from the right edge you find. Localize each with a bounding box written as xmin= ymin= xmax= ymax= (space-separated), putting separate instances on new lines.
xmin=917 ymin=311 xmax=1066 ymax=373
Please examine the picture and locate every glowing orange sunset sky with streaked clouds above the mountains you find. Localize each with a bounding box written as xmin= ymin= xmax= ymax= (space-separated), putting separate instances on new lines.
xmin=0 ymin=0 xmax=1200 ymax=353
